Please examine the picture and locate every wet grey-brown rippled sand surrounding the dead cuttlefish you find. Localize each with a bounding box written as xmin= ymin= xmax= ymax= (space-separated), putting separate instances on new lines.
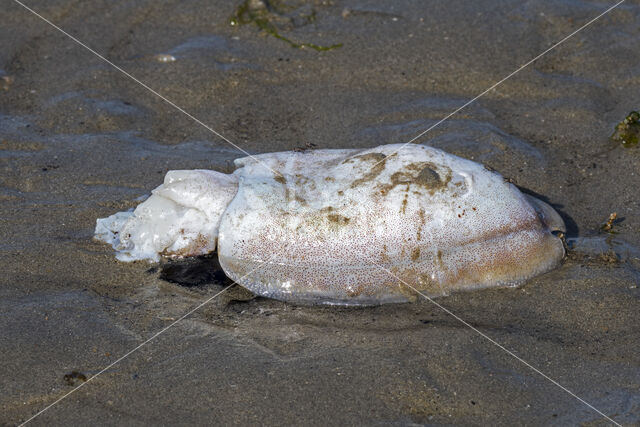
xmin=0 ymin=0 xmax=640 ymax=425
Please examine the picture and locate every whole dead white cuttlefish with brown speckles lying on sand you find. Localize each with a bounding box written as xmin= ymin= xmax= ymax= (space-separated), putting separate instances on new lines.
xmin=95 ymin=144 xmax=565 ymax=305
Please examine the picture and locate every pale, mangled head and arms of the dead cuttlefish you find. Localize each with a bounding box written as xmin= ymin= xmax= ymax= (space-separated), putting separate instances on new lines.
xmin=95 ymin=170 xmax=238 ymax=261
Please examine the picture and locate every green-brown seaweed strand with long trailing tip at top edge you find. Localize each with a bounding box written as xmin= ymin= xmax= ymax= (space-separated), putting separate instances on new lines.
xmin=229 ymin=0 xmax=342 ymax=52
